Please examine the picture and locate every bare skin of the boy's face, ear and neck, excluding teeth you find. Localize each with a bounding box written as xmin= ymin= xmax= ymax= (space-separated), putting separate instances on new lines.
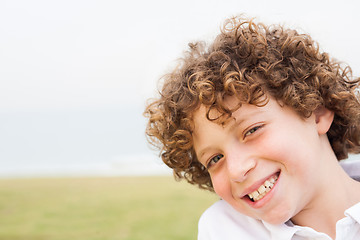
xmin=193 ymin=98 xmax=360 ymax=237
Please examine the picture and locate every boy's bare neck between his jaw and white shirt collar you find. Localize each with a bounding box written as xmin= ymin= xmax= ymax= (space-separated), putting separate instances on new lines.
xmin=291 ymin=158 xmax=360 ymax=239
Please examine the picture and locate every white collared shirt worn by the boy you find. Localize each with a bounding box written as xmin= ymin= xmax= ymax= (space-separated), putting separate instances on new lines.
xmin=198 ymin=160 xmax=360 ymax=240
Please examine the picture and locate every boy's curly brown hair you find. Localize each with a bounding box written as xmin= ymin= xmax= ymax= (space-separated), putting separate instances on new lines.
xmin=144 ymin=17 xmax=360 ymax=190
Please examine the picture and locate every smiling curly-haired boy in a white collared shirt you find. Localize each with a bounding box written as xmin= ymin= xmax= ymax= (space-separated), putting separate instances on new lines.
xmin=145 ymin=15 xmax=360 ymax=240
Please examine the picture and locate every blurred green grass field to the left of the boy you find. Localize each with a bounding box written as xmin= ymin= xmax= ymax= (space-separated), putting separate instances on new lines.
xmin=0 ymin=176 xmax=218 ymax=240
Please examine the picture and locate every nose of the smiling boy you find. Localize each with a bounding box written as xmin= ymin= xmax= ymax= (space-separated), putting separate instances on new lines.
xmin=225 ymin=144 xmax=257 ymax=182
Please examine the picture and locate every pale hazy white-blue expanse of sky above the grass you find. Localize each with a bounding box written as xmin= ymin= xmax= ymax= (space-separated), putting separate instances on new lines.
xmin=0 ymin=0 xmax=360 ymax=177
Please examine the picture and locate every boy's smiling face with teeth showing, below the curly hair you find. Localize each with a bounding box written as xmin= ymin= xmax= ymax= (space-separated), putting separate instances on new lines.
xmin=193 ymin=99 xmax=329 ymax=224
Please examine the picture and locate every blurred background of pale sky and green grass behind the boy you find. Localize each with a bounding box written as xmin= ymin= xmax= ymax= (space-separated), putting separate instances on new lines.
xmin=0 ymin=0 xmax=360 ymax=239
